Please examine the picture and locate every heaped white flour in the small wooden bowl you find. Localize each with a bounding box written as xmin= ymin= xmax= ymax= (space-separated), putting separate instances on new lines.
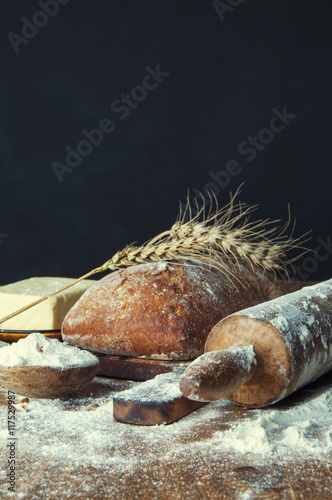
xmin=0 ymin=332 xmax=98 ymax=369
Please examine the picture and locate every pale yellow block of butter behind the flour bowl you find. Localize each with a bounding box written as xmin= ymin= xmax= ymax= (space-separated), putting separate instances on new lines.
xmin=0 ymin=277 xmax=96 ymax=331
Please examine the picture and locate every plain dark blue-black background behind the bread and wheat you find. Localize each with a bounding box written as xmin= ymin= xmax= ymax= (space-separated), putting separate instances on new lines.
xmin=0 ymin=0 xmax=332 ymax=284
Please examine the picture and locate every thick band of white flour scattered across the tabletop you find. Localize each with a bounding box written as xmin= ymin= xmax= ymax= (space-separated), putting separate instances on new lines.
xmin=0 ymin=377 xmax=332 ymax=464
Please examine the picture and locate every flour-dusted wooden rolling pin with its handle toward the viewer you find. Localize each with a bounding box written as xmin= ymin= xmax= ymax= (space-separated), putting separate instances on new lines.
xmin=180 ymin=279 xmax=332 ymax=408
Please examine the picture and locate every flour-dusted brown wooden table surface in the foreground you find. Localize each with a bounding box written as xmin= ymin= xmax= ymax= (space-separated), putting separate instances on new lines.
xmin=0 ymin=373 xmax=332 ymax=500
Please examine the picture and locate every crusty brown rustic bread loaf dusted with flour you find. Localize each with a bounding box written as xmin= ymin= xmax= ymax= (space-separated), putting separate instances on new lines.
xmin=62 ymin=261 xmax=300 ymax=360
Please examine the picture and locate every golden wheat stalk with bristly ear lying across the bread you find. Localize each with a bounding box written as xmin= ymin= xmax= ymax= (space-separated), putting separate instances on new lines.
xmin=0 ymin=189 xmax=307 ymax=324
